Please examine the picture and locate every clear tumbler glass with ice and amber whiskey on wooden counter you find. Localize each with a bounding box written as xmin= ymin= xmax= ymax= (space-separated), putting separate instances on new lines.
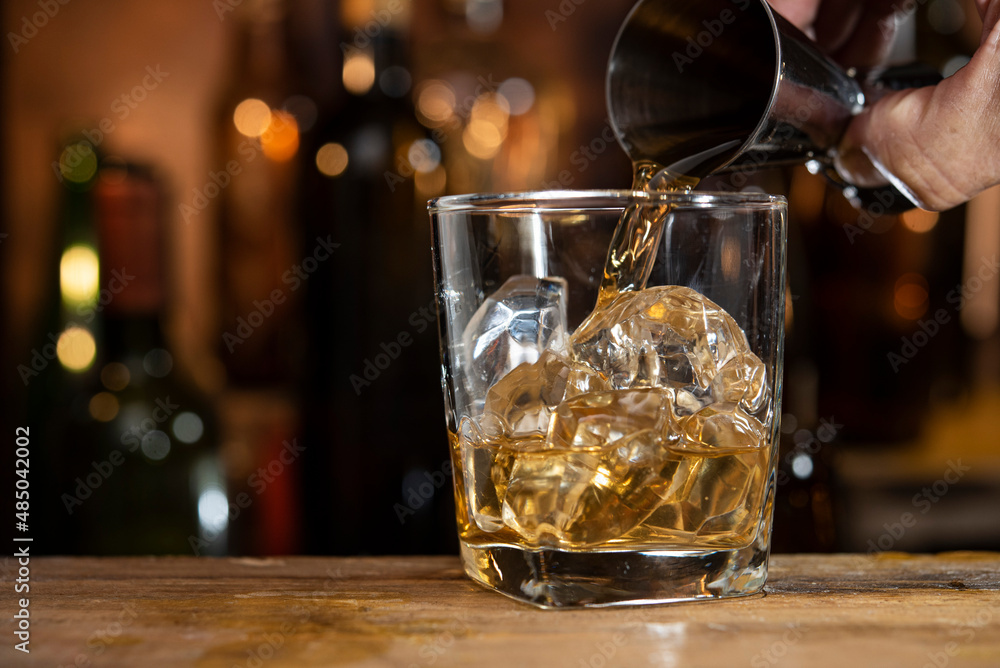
xmin=428 ymin=191 xmax=786 ymax=607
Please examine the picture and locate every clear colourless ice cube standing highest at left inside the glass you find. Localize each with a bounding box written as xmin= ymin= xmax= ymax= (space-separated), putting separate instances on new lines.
xmin=457 ymin=275 xmax=568 ymax=415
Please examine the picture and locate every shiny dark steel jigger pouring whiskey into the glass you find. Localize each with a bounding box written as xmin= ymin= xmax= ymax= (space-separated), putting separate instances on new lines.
xmin=607 ymin=0 xmax=928 ymax=210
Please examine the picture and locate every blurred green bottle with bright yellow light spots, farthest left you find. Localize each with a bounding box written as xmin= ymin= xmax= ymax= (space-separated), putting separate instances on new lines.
xmin=27 ymin=137 xmax=103 ymax=554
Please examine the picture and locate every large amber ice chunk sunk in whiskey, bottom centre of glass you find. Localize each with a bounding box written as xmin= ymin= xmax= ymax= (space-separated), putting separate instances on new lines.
xmin=494 ymin=389 xmax=676 ymax=548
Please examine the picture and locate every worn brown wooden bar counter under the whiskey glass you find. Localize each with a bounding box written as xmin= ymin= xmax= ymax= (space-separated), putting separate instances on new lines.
xmin=7 ymin=552 xmax=1000 ymax=668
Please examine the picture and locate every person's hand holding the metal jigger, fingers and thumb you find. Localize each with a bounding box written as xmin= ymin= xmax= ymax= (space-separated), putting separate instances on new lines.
xmin=769 ymin=0 xmax=1000 ymax=210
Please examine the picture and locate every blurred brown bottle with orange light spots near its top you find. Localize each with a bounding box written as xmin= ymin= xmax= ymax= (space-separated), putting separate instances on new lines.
xmin=213 ymin=0 xmax=330 ymax=554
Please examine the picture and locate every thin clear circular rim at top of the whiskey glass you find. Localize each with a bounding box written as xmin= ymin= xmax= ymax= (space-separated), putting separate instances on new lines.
xmin=427 ymin=189 xmax=788 ymax=213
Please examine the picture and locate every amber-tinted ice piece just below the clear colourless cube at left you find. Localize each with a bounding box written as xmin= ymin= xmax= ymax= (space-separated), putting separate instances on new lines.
xmin=485 ymin=350 xmax=607 ymax=438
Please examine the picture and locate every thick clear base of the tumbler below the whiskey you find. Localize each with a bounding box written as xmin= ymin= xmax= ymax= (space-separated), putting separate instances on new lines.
xmin=461 ymin=542 xmax=768 ymax=608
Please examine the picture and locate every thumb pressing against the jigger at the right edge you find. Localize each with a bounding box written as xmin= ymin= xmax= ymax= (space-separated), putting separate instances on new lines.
xmin=836 ymin=15 xmax=1000 ymax=210
